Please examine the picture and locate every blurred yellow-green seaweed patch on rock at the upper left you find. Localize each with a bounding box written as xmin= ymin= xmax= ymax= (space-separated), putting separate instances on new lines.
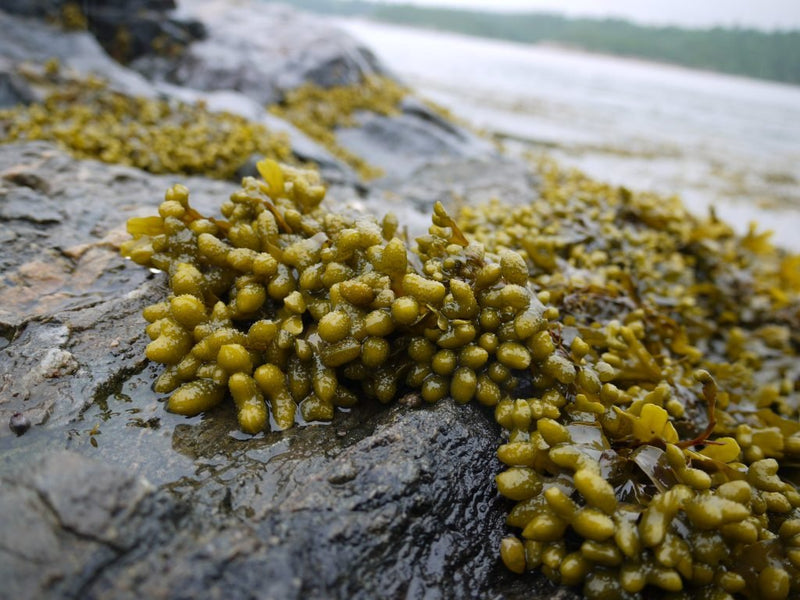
xmin=0 ymin=70 xmax=296 ymax=179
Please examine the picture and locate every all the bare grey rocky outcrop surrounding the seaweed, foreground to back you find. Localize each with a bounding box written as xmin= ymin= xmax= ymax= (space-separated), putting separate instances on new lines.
xmin=0 ymin=2 xmax=556 ymax=599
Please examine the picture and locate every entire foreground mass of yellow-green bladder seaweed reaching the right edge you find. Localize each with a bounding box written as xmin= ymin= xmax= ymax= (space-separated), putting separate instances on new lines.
xmin=122 ymin=161 xmax=800 ymax=600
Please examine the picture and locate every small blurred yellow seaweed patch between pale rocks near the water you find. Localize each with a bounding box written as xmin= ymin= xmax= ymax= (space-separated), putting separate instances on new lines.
xmin=270 ymin=75 xmax=408 ymax=180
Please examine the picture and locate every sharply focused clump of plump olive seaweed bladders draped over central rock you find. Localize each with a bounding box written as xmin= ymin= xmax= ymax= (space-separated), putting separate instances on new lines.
xmin=122 ymin=161 xmax=553 ymax=433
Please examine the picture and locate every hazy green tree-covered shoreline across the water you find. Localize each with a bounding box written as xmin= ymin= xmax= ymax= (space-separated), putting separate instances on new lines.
xmin=282 ymin=0 xmax=800 ymax=85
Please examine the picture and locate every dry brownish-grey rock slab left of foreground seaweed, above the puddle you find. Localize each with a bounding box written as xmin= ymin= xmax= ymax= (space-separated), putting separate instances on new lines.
xmin=0 ymin=143 xmax=238 ymax=436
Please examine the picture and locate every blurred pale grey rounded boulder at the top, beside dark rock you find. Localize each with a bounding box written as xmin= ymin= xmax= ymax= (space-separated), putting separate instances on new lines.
xmin=131 ymin=0 xmax=383 ymax=106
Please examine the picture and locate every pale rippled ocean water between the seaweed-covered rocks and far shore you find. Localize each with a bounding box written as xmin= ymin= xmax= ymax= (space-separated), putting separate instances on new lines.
xmin=336 ymin=19 xmax=800 ymax=251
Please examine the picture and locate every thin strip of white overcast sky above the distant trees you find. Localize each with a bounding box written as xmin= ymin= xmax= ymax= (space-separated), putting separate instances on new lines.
xmin=374 ymin=0 xmax=800 ymax=29
